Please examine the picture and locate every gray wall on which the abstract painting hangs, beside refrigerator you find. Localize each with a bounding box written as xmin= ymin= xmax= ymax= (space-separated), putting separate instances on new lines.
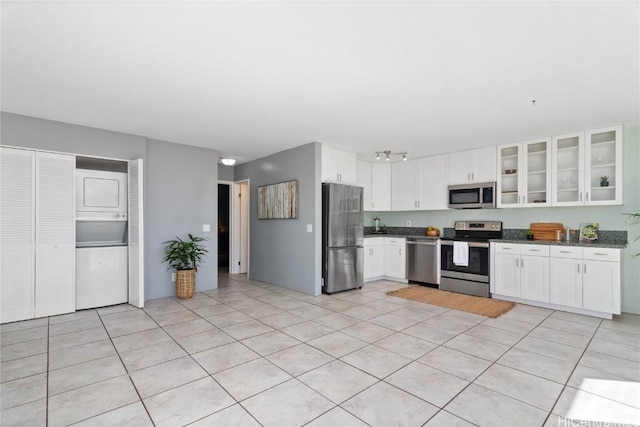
xmin=234 ymin=143 xmax=322 ymax=295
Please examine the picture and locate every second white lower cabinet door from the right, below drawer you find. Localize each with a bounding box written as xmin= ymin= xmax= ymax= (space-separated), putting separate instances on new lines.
xmin=549 ymin=257 xmax=582 ymax=308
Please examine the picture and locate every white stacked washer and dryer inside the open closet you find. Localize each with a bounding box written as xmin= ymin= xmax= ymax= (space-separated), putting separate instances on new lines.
xmin=76 ymin=169 xmax=128 ymax=310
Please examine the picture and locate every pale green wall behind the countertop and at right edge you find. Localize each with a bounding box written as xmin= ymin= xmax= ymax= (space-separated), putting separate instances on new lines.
xmin=364 ymin=126 xmax=640 ymax=313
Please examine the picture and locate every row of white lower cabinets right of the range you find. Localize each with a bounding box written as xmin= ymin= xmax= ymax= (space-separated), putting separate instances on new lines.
xmin=491 ymin=243 xmax=621 ymax=318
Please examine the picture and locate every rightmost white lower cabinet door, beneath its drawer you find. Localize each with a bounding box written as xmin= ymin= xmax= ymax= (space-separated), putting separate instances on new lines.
xmin=582 ymin=261 xmax=620 ymax=314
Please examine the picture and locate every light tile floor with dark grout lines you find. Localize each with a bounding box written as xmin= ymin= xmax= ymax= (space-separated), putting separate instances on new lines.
xmin=0 ymin=276 xmax=640 ymax=427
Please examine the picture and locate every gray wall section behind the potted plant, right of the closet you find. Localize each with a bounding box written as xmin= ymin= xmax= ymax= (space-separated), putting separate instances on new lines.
xmin=145 ymin=139 xmax=218 ymax=299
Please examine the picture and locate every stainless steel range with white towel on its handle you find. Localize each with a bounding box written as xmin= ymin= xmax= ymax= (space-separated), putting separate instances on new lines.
xmin=440 ymin=221 xmax=502 ymax=297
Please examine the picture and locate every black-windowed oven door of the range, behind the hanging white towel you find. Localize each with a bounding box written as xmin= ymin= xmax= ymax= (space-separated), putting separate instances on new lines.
xmin=440 ymin=240 xmax=489 ymax=283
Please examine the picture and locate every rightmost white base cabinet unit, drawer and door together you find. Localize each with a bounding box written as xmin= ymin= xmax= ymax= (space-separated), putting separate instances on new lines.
xmin=582 ymin=248 xmax=621 ymax=314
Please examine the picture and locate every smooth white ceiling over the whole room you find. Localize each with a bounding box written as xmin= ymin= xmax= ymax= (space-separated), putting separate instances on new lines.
xmin=1 ymin=1 xmax=640 ymax=162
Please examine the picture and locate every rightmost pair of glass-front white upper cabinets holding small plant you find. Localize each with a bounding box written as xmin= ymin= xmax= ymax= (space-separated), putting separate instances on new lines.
xmin=552 ymin=126 xmax=623 ymax=206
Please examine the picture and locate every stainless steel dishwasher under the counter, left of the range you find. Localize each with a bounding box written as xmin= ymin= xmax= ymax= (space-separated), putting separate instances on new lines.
xmin=407 ymin=238 xmax=440 ymax=285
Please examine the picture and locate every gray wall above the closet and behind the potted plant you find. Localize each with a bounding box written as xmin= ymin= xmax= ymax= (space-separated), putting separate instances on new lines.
xmin=0 ymin=112 xmax=218 ymax=300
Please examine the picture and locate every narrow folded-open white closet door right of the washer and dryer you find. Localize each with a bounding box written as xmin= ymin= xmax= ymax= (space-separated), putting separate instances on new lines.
xmin=129 ymin=159 xmax=144 ymax=308
